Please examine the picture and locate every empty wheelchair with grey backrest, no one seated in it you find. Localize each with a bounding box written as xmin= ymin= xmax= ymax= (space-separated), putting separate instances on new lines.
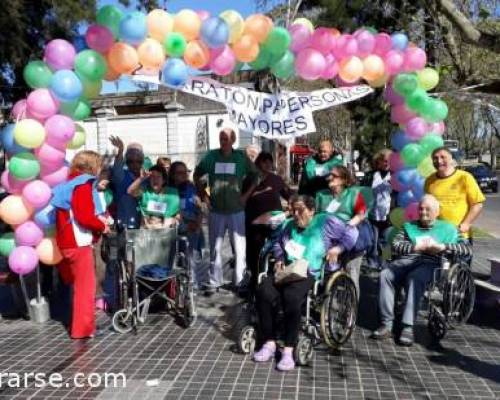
xmin=103 ymin=227 xmax=196 ymax=333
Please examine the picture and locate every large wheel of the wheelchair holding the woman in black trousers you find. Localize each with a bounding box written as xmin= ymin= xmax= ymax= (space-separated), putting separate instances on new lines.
xmin=320 ymin=271 xmax=358 ymax=348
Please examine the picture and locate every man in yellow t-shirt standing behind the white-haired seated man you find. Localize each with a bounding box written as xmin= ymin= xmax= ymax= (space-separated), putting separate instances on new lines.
xmin=425 ymin=147 xmax=486 ymax=238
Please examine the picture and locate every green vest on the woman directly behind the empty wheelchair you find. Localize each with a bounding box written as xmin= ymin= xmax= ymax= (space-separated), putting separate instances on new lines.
xmin=139 ymin=186 xmax=180 ymax=218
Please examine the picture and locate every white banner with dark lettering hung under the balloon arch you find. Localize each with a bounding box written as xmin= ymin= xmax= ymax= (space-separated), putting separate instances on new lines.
xmin=133 ymin=75 xmax=373 ymax=139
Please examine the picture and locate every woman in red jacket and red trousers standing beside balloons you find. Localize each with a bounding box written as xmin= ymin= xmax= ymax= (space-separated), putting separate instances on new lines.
xmin=51 ymin=151 xmax=109 ymax=339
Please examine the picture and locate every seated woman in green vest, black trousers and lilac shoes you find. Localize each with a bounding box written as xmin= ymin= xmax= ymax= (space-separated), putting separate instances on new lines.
xmin=254 ymin=196 xmax=358 ymax=371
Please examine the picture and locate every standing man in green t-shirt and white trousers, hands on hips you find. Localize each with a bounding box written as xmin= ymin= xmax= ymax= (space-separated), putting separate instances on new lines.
xmin=194 ymin=124 xmax=257 ymax=290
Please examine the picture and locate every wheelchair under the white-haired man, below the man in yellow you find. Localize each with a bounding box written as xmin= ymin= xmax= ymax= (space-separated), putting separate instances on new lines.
xmin=425 ymin=254 xmax=476 ymax=340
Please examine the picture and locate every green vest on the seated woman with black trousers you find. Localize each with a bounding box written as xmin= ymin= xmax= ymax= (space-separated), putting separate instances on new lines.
xmin=285 ymin=214 xmax=328 ymax=277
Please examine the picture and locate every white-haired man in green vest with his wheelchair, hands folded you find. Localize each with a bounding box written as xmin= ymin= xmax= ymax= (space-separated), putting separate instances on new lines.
xmin=372 ymin=195 xmax=473 ymax=346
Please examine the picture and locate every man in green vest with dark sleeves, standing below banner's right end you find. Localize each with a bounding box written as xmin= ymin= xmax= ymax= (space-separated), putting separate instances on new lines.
xmin=299 ymin=140 xmax=344 ymax=197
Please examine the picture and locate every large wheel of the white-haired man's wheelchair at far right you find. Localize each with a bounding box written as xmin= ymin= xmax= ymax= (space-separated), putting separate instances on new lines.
xmin=443 ymin=263 xmax=476 ymax=325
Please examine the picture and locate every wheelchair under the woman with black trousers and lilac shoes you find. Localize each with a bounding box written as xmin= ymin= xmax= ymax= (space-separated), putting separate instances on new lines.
xmin=233 ymin=245 xmax=358 ymax=365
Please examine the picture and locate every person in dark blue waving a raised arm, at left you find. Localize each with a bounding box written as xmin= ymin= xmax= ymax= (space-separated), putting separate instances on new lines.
xmin=110 ymin=136 xmax=144 ymax=229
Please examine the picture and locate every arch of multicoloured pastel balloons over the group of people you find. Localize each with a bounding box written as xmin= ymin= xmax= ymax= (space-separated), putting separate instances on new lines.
xmin=0 ymin=6 xmax=448 ymax=275
